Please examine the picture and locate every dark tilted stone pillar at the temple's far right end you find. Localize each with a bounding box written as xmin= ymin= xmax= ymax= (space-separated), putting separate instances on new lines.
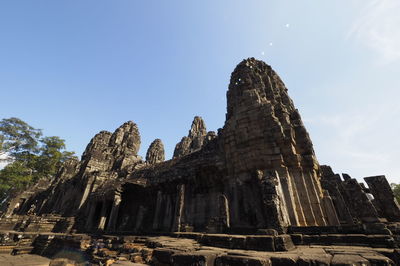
xmin=364 ymin=175 xmax=400 ymax=222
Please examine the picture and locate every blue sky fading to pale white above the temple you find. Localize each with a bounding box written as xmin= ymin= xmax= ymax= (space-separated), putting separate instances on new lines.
xmin=0 ymin=0 xmax=400 ymax=182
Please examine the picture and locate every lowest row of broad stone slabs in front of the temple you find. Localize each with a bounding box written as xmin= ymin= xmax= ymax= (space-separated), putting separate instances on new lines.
xmin=152 ymin=247 xmax=398 ymax=266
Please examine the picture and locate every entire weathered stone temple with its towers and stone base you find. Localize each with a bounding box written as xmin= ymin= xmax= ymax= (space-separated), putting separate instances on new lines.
xmin=0 ymin=58 xmax=400 ymax=265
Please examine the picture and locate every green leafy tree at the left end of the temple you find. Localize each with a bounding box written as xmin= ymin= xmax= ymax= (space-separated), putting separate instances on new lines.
xmin=0 ymin=117 xmax=75 ymax=202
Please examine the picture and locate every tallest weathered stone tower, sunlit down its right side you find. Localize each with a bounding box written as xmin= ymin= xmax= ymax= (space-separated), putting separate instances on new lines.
xmin=222 ymin=58 xmax=332 ymax=226
